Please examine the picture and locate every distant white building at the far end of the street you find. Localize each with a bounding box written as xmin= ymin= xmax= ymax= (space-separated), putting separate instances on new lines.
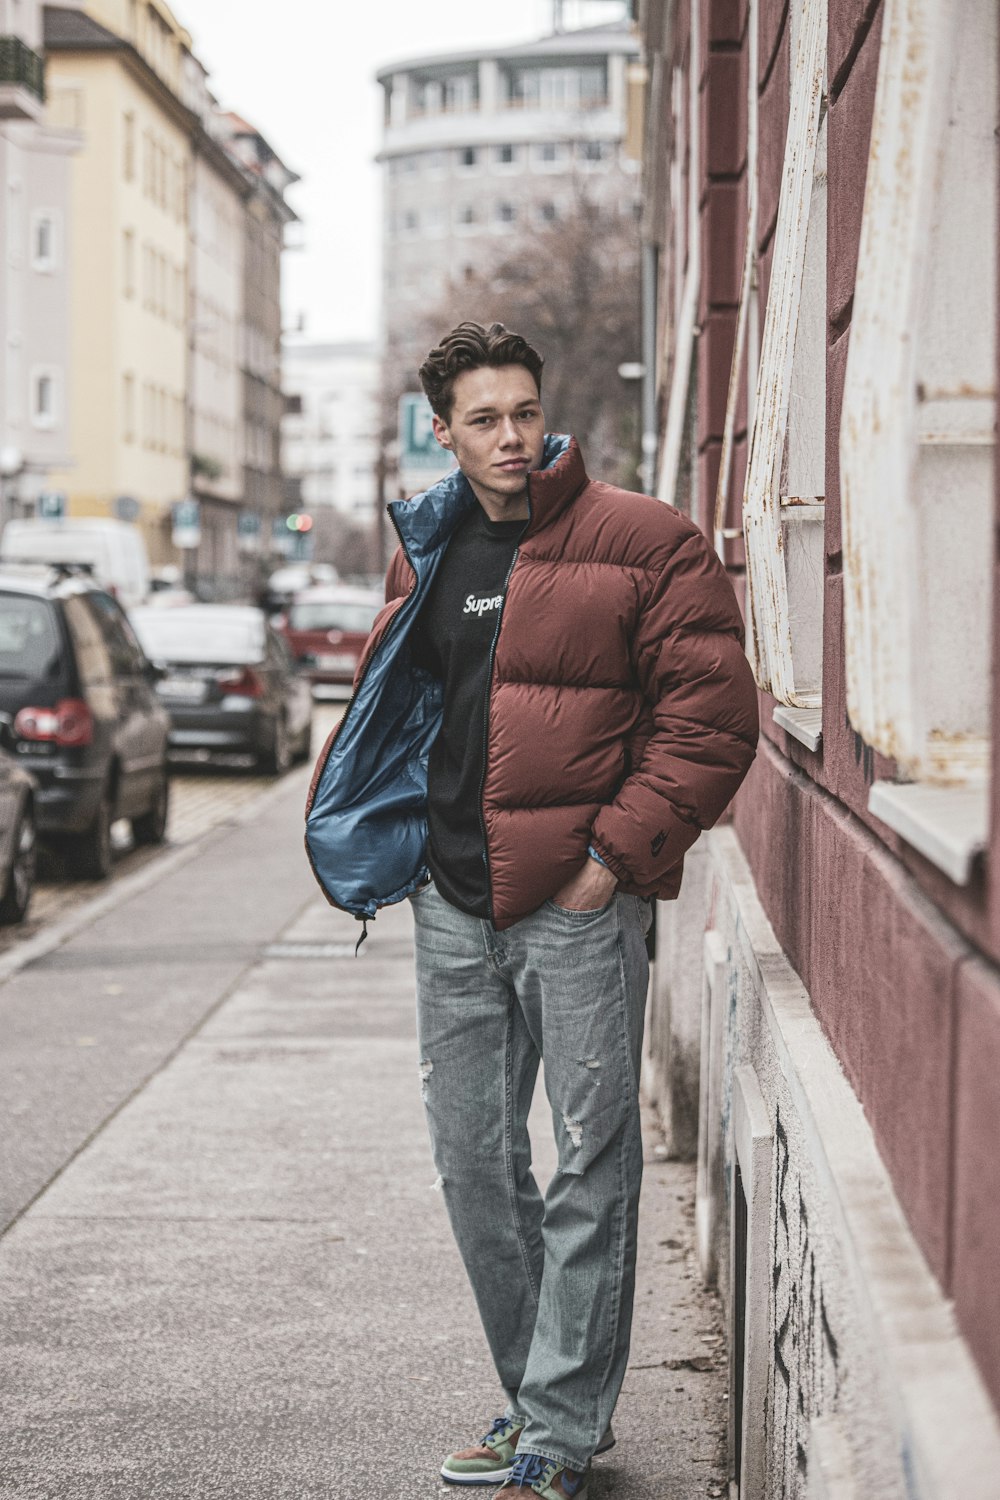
xmin=283 ymin=341 xmax=379 ymax=527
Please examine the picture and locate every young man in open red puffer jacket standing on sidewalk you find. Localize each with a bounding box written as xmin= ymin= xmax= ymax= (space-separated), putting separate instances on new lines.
xmin=307 ymin=323 xmax=757 ymax=1500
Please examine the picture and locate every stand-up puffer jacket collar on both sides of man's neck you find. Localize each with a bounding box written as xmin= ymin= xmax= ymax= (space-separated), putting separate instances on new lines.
xmin=388 ymin=432 xmax=586 ymax=564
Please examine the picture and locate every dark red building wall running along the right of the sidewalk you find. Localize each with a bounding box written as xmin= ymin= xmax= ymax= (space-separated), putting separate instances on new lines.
xmin=689 ymin=0 xmax=1000 ymax=1404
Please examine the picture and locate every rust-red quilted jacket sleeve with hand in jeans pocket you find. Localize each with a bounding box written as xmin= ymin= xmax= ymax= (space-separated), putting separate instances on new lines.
xmin=592 ymin=522 xmax=759 ymax=891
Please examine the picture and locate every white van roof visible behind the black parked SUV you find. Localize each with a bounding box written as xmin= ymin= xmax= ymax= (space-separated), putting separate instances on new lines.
xmin=0 ymin=516 xmax=150 ymax=609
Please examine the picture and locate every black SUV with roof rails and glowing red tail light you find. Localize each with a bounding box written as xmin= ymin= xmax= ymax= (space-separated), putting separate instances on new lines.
xmin=0 ymin=564 xmax=169 ymax=881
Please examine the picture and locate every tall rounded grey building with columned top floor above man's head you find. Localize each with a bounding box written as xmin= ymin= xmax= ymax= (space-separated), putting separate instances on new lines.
xmin=378 ymin=21 xmax=637 ymax=396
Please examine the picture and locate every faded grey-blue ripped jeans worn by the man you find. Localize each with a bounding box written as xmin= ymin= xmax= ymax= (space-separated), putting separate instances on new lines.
xmin=411 ymin=885 xmax=652 ymax=1469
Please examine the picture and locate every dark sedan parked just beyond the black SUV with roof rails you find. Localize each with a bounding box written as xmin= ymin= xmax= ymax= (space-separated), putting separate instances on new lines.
xmin=132 ymin=605 xmax=312 ymax=774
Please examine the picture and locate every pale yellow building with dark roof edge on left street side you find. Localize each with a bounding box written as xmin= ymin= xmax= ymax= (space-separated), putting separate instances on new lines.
xmin=45 ymin=0 xmax=192 ymax=563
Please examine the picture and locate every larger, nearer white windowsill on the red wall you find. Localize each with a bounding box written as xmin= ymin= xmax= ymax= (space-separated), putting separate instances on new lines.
xmin=868 ymin=782 xmax=990 ymax=885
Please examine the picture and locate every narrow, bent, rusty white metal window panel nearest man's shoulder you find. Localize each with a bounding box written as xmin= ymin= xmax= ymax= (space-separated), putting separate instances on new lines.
xmin=744 ymin=0 xmax=826 ymax=708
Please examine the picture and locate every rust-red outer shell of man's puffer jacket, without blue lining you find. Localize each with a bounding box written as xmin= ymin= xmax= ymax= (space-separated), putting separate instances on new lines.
xmin=366 ymin=441 xmax=757 ymax=929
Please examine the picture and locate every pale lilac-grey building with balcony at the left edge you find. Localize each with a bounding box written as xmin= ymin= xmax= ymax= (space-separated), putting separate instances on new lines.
xmin=0 ymin=0 xmax=79 ymax=522
